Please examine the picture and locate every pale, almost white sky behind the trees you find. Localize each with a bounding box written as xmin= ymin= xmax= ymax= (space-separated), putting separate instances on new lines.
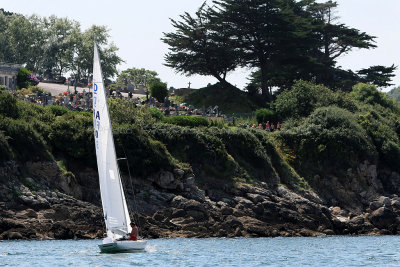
xmin=0 ymin=0 xmax=400 ymax=91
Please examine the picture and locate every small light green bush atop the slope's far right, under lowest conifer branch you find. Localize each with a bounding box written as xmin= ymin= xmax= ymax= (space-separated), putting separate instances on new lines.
xmin=351 ymin=83 xmax=394 ymax=108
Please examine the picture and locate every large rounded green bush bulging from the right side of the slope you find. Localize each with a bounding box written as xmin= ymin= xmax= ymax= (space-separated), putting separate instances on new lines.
xmin=279 ymin=107 xmax=377 ymax=170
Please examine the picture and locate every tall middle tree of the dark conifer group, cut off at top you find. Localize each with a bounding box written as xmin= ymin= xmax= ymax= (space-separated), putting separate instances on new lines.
xmin=214 ymin=0 xmax=314 ymax=100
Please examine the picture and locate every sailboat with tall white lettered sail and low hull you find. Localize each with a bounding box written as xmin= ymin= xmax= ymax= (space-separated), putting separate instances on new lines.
xmin=93 ymin=42 xmax=146 ymax=253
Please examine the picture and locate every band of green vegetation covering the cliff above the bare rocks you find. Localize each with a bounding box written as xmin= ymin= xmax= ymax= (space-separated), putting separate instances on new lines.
xmin=0 ymin=77 xmax=400 ymax=195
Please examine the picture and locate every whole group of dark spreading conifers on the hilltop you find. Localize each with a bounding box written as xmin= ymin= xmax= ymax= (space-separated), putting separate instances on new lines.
xmin=162 ymin=0 xmax=396 ymax=101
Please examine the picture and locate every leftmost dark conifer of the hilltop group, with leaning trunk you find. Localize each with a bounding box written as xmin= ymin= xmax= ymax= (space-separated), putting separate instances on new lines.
xmin=161 ymin=3 xmax=240 ymax=83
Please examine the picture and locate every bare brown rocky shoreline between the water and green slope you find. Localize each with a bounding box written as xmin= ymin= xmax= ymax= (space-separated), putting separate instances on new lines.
xmin=0 ymin=161 xmax=400 ymax=240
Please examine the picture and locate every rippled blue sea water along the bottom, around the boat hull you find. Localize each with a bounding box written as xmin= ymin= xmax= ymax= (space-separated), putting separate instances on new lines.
xmin=0 ymin=236 xmax=400 ymax=267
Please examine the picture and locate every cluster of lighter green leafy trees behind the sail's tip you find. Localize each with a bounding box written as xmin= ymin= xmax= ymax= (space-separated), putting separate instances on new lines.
xmin=0 ymin=9 xmax=123 ymax=79
